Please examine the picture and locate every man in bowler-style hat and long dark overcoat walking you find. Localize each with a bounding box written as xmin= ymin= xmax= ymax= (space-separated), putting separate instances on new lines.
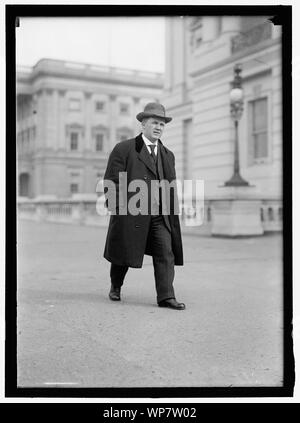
xmin=104 ymin=103 xmax=185 ymax=310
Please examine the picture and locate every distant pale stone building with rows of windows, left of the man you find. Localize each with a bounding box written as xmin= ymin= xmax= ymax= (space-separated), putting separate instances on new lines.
xmin=17 ymin=59 xmax=163 ymax=198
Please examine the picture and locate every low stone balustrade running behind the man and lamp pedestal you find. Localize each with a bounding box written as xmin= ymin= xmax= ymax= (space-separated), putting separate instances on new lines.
xmin=18 ymin=197 xmax=282 ymax=234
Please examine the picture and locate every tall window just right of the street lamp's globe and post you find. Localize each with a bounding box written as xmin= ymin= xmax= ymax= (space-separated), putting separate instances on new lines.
xmin=249 ymin=98 xmax=269 ymax=162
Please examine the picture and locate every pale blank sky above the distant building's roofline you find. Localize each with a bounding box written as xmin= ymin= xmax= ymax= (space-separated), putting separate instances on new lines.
xmin=16 ymin=17 xmax=165 ymax=72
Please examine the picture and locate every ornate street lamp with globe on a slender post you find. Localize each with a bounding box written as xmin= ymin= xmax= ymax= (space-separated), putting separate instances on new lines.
xmin=224 ymin=63 xmax=249 ymax=187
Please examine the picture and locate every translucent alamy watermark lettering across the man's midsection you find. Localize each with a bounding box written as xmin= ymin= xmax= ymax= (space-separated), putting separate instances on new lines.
xmin=96 ymin=172 xmax=204 ymax=226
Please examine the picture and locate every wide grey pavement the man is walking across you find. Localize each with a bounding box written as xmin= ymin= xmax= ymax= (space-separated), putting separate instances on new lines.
xmin=17 ymin=221 xmax=283 ymax=387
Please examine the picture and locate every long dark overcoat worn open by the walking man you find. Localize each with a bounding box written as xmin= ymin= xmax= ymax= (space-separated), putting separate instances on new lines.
xmin=104 ymin=134 xmax=183 ymax=268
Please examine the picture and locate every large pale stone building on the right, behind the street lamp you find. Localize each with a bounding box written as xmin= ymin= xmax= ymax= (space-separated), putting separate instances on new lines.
xmin=163 ymin=16 xmax=282 ymax=197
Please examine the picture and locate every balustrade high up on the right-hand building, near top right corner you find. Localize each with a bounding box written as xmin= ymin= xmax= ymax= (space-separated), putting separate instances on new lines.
xmin=231 ymin=22 xmax=272 ymax=54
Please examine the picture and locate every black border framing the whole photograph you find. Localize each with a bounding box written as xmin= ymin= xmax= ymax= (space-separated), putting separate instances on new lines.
xmin=5 ymin=5 xmax=295 ymax=399
